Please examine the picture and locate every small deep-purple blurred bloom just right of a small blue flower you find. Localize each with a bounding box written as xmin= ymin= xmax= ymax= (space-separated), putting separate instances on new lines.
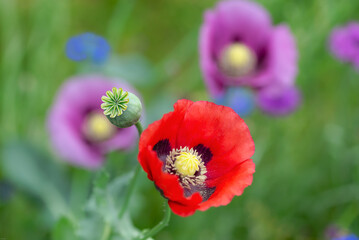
xmin=257 ymin=87 xmax=301 ymax=115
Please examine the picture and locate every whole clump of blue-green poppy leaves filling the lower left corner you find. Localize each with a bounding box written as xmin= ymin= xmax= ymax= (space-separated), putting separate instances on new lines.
xmin=2 ymin=142 xmax=151 ymax=240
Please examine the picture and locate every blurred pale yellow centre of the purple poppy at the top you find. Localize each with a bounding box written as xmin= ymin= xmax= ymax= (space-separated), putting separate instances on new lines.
xmin=219 ymin=43 xmax=257 ymax=77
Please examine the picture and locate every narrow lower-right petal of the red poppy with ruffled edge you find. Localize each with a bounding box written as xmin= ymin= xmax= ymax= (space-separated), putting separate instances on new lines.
xmin=199 ymin=159 xmax=255 ymax=211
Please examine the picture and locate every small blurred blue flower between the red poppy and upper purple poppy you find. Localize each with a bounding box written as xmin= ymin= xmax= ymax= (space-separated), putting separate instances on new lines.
xmin=214 ymin=87 xmax=255 ymax=117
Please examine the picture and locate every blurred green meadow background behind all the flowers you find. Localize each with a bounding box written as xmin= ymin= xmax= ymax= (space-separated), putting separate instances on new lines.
xmin=0 ymin=0 xmax=359 ymax=240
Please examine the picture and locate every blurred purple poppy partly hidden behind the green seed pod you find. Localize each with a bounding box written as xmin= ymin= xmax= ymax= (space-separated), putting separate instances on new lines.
xmin=47 ymin=75 xmax=138 ymax=168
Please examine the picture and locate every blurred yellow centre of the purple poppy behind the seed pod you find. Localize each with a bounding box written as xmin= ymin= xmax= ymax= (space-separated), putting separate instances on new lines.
xmin=84 ymin=112 xmax=116 ymax=142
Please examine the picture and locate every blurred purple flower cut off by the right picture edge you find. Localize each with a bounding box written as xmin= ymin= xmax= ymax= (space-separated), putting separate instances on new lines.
xmin=329 ymin=22 xmax=359 ymax=69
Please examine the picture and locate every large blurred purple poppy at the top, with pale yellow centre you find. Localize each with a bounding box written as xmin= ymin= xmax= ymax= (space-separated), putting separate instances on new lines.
xmin=199 ymin=0 xmax=297 ymax=97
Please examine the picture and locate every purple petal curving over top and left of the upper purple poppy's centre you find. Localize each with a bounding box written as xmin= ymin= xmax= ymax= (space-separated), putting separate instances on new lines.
xmin=199 ymin=0 xmax=271 ymax=96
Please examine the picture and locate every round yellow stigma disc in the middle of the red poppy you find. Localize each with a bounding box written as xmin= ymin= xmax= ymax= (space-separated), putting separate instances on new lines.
xmin=175 ymin=152 xmax=200 ymax=176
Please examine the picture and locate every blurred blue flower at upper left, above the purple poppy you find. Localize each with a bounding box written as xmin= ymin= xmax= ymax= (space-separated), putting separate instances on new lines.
xmin=66 ymin=33 xmax=111 ymax=64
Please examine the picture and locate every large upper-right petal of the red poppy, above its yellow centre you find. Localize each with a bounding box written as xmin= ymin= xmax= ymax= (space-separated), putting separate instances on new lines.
xmin=175 ymin=101 xmax=254 ymax=179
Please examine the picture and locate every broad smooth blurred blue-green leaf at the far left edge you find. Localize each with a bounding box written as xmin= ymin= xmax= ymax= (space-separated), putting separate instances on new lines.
xmin=2 ymin=141 xmax=70 ymax=218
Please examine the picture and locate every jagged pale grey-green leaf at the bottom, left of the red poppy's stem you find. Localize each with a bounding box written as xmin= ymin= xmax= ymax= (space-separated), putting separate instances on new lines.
xmin=77 ymin=171 xmax=148 ymax=240
